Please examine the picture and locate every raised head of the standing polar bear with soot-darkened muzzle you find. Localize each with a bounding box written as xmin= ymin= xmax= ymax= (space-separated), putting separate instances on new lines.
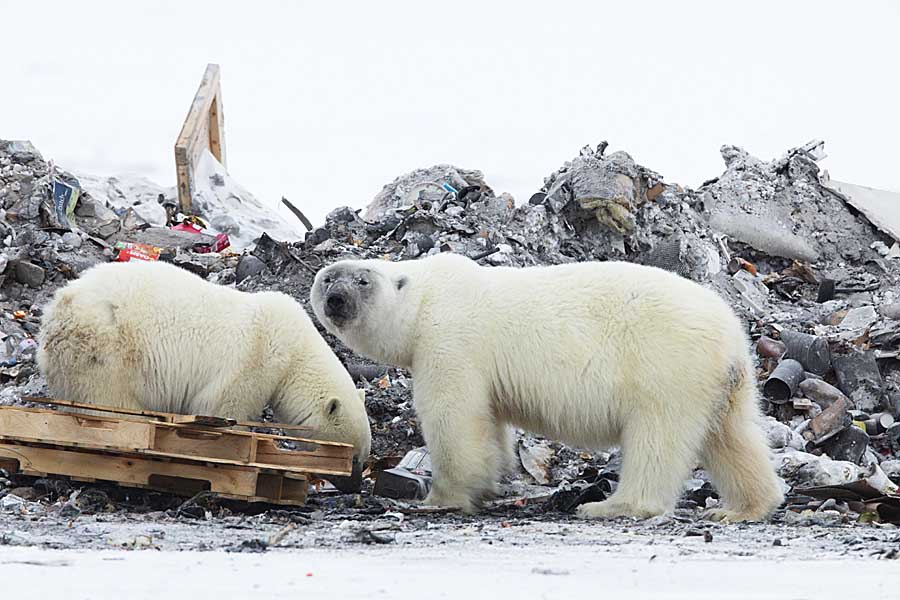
xmin=310 ymin=260 xmax=419 ymax=367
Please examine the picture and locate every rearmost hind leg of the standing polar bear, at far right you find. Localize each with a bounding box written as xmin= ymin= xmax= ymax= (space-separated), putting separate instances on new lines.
xmin=703 ymin=357 xmax=784 ymax=521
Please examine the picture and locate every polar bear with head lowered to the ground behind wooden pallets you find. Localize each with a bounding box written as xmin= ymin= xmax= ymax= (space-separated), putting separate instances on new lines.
xmin=37 ymin=261 xmax=371 ymax=489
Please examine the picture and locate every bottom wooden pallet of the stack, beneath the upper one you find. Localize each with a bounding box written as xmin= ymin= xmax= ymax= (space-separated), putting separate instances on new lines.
xmin=0 ymin=441 xmax=307 ymax=506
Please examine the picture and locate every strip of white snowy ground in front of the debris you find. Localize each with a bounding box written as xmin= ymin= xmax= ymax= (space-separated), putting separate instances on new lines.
xmin=0 ymin=526 xmax=900 ymax=600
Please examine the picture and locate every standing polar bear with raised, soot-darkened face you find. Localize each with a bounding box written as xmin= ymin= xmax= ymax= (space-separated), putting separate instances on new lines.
xmin=311 ymin=254 xmax=782 ymax=520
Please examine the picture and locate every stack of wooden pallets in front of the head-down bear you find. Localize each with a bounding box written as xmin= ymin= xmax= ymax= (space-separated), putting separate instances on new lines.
xmin=0 ymin=398 xmax=353 ymax=505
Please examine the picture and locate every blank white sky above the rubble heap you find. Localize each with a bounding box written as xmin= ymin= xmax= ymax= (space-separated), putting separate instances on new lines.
xmin=0 ymin=0 xmax=900 ymax=222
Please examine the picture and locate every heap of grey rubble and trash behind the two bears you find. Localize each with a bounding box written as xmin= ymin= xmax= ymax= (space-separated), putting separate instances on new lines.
xmin=0 ymin=141 xmax=900 ymax=539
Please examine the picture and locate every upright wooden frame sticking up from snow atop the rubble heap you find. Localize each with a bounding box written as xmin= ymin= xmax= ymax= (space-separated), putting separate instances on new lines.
xmin=175 ymin=64 xmax=225 ymax=214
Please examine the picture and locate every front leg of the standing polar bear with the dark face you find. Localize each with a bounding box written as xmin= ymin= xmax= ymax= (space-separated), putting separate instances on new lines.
xmin=413 ymin=373 xmax=508 ymax=513
